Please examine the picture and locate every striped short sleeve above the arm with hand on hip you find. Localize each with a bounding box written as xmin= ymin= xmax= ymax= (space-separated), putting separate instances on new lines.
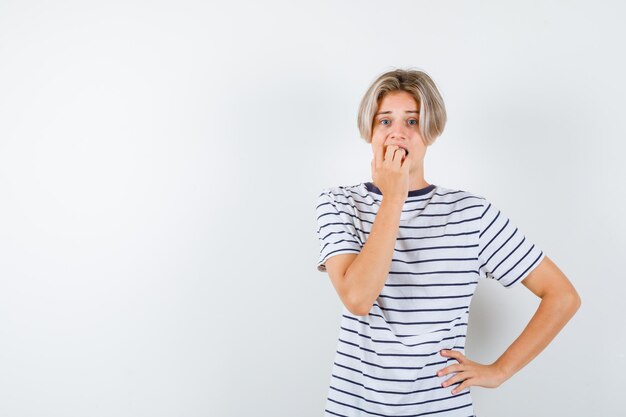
xmin=478 ymin=199 xmax=545 ymax=288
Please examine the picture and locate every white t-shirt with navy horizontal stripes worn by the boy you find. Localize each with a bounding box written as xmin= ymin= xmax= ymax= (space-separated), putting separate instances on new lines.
xmin=316 ymin=182 xmax=544 ymax=417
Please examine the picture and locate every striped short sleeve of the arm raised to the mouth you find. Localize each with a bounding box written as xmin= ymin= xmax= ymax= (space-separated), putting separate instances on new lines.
xmin=315 ymin=190 xmax=362 ymax=272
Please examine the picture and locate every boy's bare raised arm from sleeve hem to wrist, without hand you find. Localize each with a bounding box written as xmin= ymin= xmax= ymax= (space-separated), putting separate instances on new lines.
xmin=326 ymin=198 xmax=403 ymax=316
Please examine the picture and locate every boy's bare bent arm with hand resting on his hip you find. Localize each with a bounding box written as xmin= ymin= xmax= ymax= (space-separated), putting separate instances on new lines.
xmin=437 ymin=256 xmax=581 ymax=394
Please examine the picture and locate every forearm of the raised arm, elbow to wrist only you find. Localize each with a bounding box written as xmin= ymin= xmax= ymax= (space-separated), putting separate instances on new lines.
xmin=345 ymin=198 xmax=403 ymax=314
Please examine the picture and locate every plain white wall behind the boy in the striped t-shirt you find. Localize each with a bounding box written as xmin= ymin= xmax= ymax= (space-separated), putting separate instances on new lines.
xmin=0 ymin=0 xmax=626 ymax=417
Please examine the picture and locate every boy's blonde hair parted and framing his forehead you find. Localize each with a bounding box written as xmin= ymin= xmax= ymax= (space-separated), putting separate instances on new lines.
xmin=357 ymin=69 xmax=447 ymax=146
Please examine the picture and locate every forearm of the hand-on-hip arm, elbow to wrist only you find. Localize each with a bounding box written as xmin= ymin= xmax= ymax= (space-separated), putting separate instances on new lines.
xmin=494 ymin=293 xmax=580 ymax=382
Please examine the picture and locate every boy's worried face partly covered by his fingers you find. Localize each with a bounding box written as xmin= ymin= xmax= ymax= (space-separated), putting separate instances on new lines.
xmin=372 ymin=91 xmax=427 ymax=170
